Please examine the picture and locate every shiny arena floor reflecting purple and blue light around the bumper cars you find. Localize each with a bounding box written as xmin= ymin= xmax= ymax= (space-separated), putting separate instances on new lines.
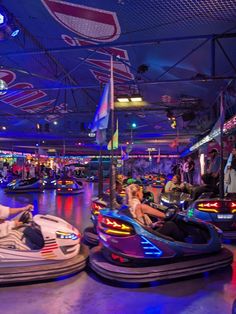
xmin=0 ymin=183 xmax=236 ymax=314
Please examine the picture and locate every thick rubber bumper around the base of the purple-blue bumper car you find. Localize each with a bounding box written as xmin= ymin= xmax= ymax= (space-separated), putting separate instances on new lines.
xmin=89 ymin=246 xmax=233 ymax=283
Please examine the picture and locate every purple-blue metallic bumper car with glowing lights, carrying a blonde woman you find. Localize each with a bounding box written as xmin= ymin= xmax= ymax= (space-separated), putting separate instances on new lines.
xmin=90 ymin=208 xmax=233 ymax=283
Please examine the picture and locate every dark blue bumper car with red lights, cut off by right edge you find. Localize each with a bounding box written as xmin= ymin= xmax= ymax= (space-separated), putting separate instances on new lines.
xmin=187 ymin=193 xmax=236 ymax=239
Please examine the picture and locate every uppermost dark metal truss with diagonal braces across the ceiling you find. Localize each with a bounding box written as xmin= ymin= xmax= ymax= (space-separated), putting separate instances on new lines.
xmin=1 ymin=33 xmax=236 ymax=91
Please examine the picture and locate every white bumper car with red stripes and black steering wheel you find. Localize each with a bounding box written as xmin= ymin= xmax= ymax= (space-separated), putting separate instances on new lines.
xmin=0 ymin=212 xmax=88 ymax=284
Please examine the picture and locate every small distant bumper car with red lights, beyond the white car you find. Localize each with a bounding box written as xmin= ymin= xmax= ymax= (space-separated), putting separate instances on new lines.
xmin=56 ymin=178 xmax=84 ymax=195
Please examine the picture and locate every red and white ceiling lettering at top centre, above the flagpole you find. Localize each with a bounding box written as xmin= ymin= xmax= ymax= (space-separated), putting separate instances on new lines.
xmin=41 ymin=0 xmax=134 ymax=91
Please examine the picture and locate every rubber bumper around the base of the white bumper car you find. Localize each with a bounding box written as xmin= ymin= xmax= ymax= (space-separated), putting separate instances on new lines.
xmin=0 ymin=245 xmax=89 ymax=285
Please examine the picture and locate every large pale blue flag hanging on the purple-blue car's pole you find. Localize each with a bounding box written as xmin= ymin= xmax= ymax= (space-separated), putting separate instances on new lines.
xmin=91 ymin=82 xmax=110 ymax=144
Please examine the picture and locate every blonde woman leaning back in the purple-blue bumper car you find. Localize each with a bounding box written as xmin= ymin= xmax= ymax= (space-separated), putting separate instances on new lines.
xmin=126 ymin=184 xmax=184 ymax=241
